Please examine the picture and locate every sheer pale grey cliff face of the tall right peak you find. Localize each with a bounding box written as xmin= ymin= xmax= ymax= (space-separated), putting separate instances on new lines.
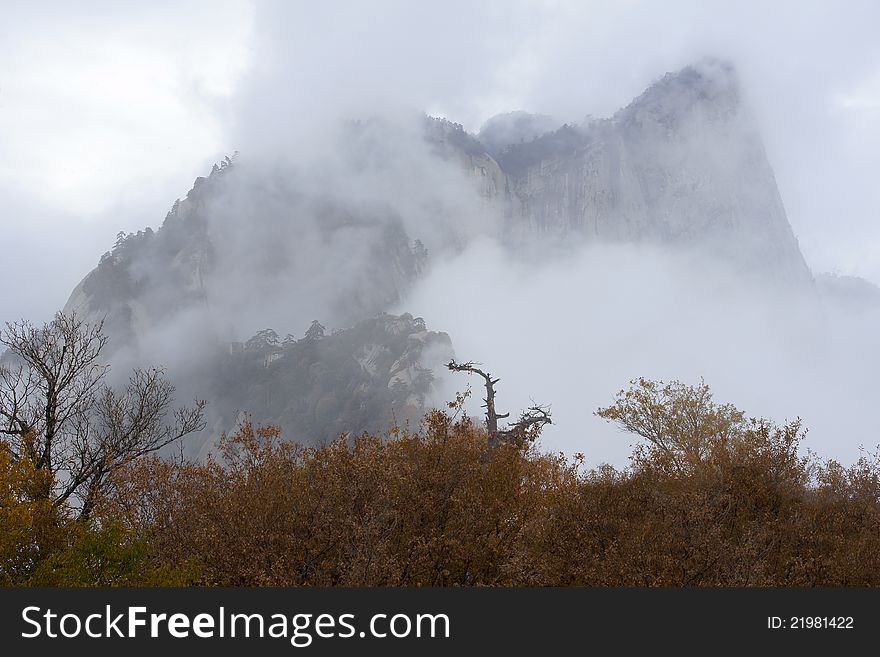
xmin=498 ymin=60 xmax=811 ymax=285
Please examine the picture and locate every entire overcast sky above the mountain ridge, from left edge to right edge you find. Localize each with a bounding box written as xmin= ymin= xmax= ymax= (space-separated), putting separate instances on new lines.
xmin=0 ymin=0 xmax=880 ymax=320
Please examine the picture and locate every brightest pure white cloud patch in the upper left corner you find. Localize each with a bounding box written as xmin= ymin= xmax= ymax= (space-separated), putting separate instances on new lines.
xmin=0 ymin=3 xmax=249 ymax=219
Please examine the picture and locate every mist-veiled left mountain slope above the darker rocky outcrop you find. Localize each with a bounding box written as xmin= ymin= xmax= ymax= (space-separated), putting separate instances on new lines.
xmin=95 ymin=115 xmax=503 ymax=354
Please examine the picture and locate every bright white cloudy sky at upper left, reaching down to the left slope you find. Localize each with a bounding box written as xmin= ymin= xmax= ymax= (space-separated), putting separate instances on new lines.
xmin=0 ymin=1 xmax=252 ymax=321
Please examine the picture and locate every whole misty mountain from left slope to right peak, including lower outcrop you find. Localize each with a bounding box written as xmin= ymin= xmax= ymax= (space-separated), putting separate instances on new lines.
xmin=60 ymin=60 xmax=814 ymax=452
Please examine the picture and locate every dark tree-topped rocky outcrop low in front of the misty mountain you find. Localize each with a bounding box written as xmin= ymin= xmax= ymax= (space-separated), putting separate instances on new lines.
xmin=207 ymin=313 xmax=452 ymax=442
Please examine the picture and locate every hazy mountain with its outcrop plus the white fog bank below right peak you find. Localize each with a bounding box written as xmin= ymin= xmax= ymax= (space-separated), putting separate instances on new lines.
xmin=58 ymin=59 xmax=876 ymax=460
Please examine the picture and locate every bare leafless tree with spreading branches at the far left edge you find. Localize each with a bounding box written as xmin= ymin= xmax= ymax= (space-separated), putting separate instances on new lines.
xmin=0 ymin=313 xmax=205 ymax=517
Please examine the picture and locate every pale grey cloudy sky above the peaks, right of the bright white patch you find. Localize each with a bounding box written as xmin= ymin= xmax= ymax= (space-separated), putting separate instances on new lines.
xmin=228 ymin=0 xmax=880 ymax=283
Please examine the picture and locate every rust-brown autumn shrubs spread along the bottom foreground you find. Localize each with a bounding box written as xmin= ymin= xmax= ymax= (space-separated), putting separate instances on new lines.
xmin=0 ymin=380 xmax=880 ymax=586
